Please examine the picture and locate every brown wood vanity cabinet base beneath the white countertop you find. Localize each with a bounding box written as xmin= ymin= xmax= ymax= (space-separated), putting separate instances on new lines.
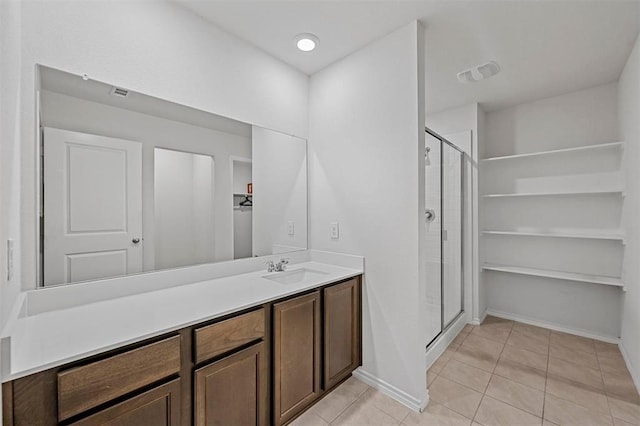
xmin=2 ymin=277 xmax=361 ymax=426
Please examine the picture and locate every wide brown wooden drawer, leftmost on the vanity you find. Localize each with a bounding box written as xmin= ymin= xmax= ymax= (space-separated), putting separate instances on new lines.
xmin=58 ymin=336 xmax=180 ymax=420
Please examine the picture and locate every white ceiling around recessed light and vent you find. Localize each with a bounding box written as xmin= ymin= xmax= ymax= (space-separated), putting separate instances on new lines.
xmin=178 ymin=0 xmax=640 ymax=112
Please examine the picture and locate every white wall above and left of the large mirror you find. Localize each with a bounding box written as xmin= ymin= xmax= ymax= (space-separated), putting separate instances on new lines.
xmin=8 ymin=0 xmax=308 ymax=318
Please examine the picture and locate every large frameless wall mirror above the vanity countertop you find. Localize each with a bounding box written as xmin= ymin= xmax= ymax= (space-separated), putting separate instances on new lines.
xmin=38 ymin=66 xmax=307 ymax=286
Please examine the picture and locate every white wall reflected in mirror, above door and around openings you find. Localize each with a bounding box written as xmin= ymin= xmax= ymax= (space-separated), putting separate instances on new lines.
xmin=41 ymin=90 xmax=251 ymax=270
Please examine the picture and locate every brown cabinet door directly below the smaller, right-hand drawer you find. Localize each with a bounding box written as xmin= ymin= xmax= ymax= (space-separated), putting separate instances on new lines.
xmin=195 ymin=342 xmax=268 ymax=426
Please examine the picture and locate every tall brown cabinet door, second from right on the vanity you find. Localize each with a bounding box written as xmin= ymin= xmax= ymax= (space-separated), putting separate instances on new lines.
xmin=273 ymin=291 xmax=321 ymax=425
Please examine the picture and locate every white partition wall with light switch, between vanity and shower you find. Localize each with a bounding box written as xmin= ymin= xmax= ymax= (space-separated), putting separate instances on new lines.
xmin=309 ymin=22 xmax=428 ymax=406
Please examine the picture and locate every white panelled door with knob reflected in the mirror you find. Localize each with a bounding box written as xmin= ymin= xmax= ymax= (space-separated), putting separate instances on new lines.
xmin=43 ymin=128 xmax=142 ymax=285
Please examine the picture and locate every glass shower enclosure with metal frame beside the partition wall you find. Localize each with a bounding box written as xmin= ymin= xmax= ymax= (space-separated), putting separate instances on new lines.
xmin=424 ymin=129 xmax=465 ymax=342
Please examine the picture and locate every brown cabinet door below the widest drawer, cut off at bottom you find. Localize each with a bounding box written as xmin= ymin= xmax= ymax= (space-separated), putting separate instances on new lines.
xmin=72 ymin=379 xmax=180 ymax=426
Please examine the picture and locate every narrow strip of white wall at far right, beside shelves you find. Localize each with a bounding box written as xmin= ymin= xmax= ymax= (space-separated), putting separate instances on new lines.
xmin=618 ymin=33 xmax=640 ymax=388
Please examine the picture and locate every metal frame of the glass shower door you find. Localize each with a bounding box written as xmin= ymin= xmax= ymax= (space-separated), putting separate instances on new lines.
xmin=424 ymin=126 xmax=467 ymax=348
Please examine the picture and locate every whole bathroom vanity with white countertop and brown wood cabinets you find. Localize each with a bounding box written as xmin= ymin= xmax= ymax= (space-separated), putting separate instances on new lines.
xmin=2 ymin=261 xmax=362 ymax=426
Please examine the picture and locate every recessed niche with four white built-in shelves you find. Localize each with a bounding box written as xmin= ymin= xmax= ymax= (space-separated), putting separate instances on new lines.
xmin=480 ymin=142 xmax=624 ymax=287
